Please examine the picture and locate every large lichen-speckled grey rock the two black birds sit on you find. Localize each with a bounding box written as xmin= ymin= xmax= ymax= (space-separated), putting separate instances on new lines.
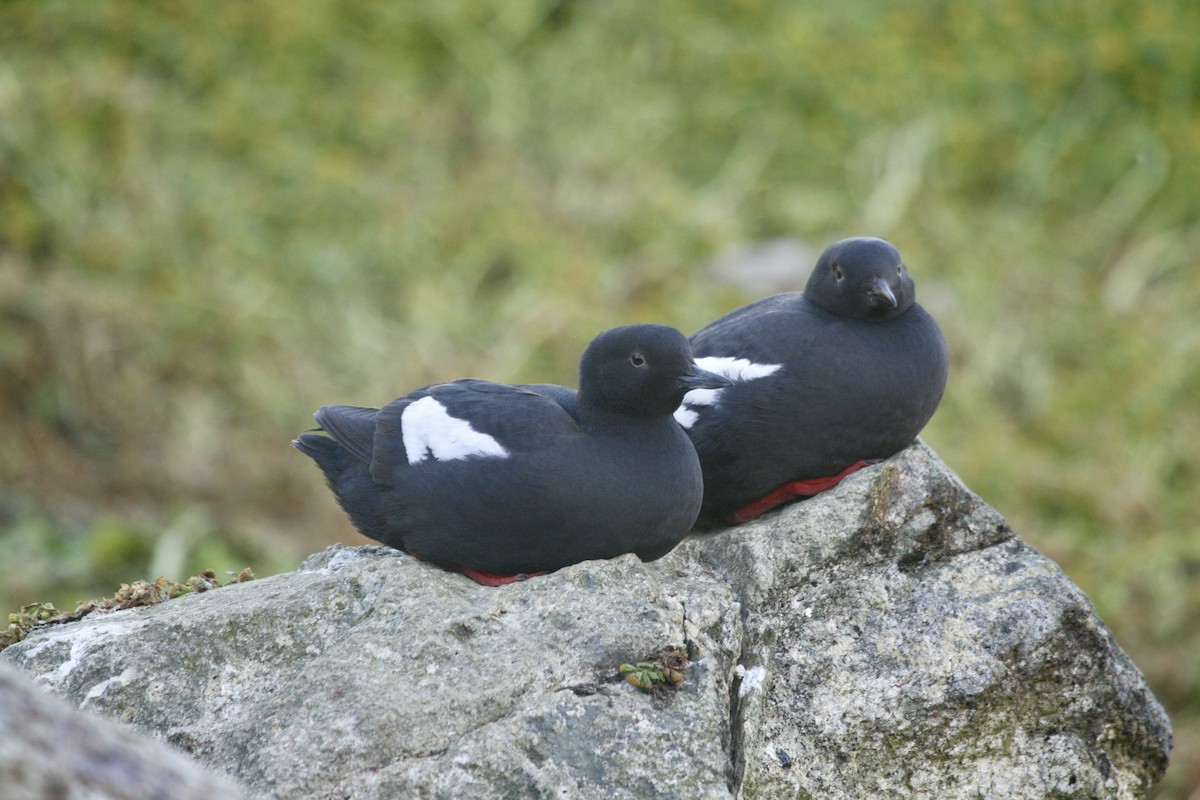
xmin=0 ymin=445 xmax=1170 ymax=800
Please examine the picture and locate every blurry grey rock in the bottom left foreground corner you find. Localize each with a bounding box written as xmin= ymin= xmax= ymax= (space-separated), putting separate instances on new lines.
xmin=0 ymin=663 xmax=245 ymax=800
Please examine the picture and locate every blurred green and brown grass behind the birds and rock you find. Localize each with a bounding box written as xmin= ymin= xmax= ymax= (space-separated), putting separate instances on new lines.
xmin=0 ymin=0 xmax=1200 ymax=798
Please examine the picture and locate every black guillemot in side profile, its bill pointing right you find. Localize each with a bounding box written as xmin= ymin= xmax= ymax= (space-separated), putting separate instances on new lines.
xmin=293 ymin=325 xmax=732 ymax=585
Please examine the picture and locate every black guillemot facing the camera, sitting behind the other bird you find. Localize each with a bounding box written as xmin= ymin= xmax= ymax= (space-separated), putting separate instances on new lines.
xmin=676 ymin=237 xmax=947 ymax=528
